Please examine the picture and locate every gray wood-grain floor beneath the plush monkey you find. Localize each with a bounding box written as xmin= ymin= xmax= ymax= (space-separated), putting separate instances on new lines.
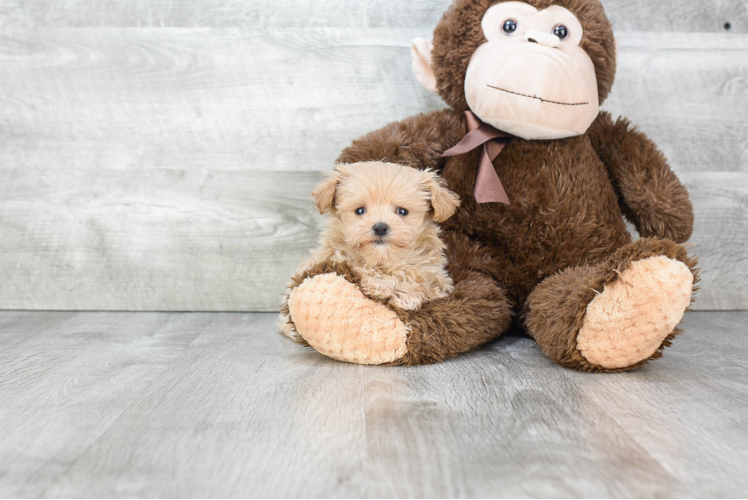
xmin=0 ymin=312 xmax=748 ymax=498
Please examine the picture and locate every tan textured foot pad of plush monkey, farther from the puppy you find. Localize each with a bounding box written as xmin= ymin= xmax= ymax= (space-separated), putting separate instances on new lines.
xmin=577 ymin=256 xmax=693 ymax=369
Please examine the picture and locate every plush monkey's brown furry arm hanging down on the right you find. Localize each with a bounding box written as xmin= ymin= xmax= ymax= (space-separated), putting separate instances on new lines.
xmin=589 ymin=112 xmax=694 ymax=243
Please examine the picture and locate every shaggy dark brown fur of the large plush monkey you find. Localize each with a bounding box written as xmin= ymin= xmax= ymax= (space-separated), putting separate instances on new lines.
xmin=284 ymin=0 xmax=698 ymax=372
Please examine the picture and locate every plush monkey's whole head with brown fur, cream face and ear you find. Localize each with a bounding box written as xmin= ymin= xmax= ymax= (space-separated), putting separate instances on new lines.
xmin=412 ymin=0 xmax=615 ymax=140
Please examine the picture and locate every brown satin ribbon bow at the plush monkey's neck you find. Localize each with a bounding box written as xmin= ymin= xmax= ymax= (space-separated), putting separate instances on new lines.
xmin=442 ymin=111 xmax=513 ymax=205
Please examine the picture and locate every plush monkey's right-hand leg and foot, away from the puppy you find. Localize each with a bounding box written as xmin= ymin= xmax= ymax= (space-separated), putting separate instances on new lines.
xmin=525 ymin=238 xmax=698 ymax=372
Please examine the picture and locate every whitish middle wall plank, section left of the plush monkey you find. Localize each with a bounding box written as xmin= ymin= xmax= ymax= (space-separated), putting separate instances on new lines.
xmin=0 ymin=29 xmax=443 ymax=175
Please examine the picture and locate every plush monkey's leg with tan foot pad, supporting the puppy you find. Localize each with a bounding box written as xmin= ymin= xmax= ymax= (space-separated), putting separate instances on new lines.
xmin=286 ymin=232 xmax=512 ymax=365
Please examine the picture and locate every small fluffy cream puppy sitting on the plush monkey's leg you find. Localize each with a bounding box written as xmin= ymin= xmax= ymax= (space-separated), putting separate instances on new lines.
xmin=282 ymin=162 xmax=460 ymax=333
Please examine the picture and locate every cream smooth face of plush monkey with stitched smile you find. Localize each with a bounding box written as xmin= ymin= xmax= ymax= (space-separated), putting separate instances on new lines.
xmin=465 ymin=2 xmax=600 ymax=139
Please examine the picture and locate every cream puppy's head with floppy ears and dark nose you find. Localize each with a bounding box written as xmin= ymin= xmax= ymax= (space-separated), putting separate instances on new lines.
xmin=314 ymin=163 xmax=459 ymax=264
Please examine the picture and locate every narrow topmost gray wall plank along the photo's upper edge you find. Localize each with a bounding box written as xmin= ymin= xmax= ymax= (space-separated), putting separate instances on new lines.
xmin=0 ymin=0 xmax=748 ymax=33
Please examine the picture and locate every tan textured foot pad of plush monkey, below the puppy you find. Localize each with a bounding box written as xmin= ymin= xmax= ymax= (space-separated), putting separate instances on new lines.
xmin=288 ymin=273 xmax=408 ymax=365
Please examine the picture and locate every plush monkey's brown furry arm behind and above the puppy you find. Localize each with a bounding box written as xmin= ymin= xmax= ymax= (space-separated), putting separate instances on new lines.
xmin=338 ymin=109 xmax=466 ymax=171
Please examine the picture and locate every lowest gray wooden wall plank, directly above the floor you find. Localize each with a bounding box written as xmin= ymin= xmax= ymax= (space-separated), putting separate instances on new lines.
xmin=0 ymin=170 xmax=748 ymax=311
